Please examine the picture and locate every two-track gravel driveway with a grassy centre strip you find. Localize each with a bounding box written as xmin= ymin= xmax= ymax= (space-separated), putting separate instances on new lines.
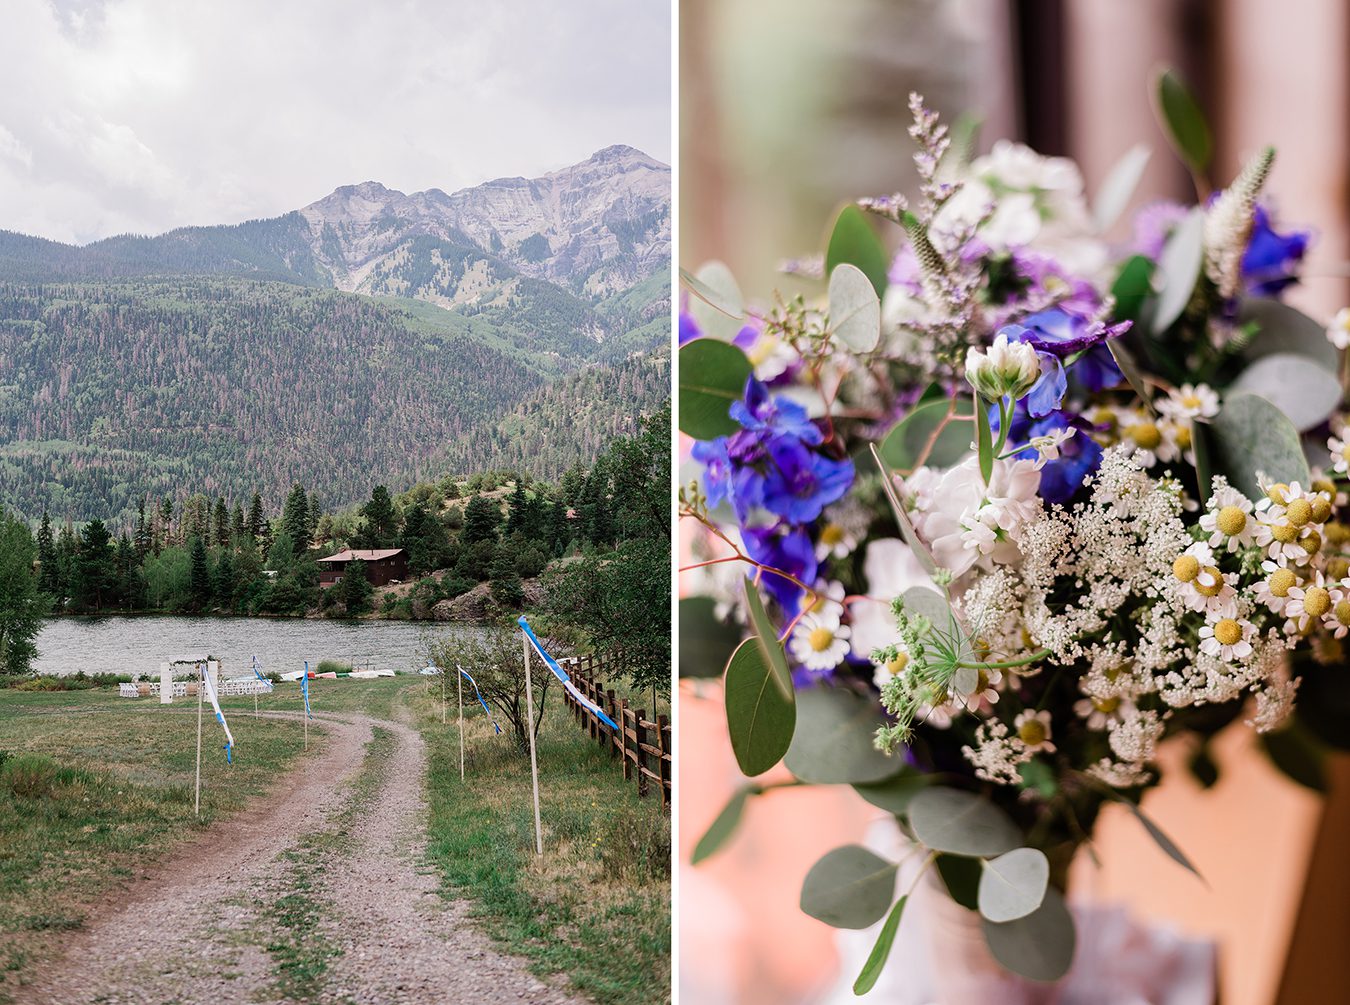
xmin=16 ymin=713 xmax=578 ymax=1005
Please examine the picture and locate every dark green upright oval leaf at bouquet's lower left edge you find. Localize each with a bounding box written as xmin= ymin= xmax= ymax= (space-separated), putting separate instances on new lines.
xmin=724 ymin=639 xmax=797 ymax=777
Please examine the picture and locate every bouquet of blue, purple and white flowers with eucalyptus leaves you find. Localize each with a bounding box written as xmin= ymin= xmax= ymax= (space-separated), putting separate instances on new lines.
xmin=679 ymin=73 xmax=1350 ymax=993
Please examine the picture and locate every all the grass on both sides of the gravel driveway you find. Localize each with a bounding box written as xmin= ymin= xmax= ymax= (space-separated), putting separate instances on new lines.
xmin=0 ymin=677 xmax=671 ymax=1005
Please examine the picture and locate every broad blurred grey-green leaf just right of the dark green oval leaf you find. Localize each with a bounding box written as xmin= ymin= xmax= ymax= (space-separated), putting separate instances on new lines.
xmin=783 ymin=688 xmax=905 ymax=785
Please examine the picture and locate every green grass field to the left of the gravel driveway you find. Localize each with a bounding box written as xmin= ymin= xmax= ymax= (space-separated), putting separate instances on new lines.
xmin=0 ymin=689 xmax=323 ymax=1002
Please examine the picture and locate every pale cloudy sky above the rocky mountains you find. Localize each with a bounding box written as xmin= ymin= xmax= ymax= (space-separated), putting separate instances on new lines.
xmin=0 ymin=0 xmax=671 ymax=243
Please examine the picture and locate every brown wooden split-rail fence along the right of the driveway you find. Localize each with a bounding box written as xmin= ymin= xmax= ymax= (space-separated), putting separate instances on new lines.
xmin=563 ymin=655 xmax=671 ymax=809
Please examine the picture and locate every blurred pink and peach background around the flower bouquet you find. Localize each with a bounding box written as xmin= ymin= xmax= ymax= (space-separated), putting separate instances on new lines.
xmin=679 ymin=0 xmax=1350 ymax=1005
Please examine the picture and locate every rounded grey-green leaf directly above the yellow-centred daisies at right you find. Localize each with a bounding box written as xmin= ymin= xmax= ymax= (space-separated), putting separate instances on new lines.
xmin=1195 ymin=392 xmax=1310 ymax=498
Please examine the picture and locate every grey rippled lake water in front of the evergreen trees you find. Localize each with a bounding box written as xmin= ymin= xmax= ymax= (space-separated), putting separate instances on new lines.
xmin=34 ymin=617 xmax=473 ymax=677
